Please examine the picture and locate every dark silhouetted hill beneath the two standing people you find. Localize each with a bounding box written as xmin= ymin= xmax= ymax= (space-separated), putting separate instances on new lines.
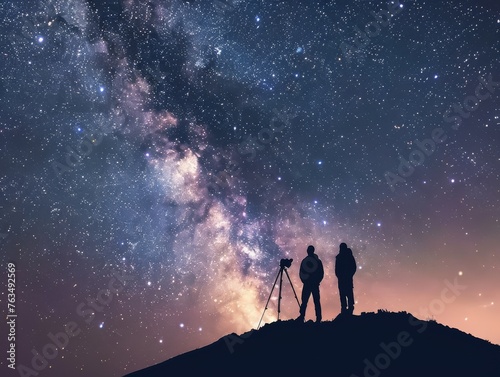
xmin=126 ymin=311 xmax=500 ymax=377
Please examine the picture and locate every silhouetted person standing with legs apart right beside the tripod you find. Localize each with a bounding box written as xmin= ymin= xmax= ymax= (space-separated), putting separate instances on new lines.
xmin=297 ymin=245 xmax=325 ymax=322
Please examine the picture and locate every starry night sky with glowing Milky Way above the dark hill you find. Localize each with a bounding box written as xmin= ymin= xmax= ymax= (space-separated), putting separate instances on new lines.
xmin=0 ymin=0 xmax=500 ymax=377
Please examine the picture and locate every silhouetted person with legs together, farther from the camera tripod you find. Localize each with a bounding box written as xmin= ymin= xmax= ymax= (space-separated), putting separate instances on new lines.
xmin=335 ymin=242 xmax=356 ymax=314
